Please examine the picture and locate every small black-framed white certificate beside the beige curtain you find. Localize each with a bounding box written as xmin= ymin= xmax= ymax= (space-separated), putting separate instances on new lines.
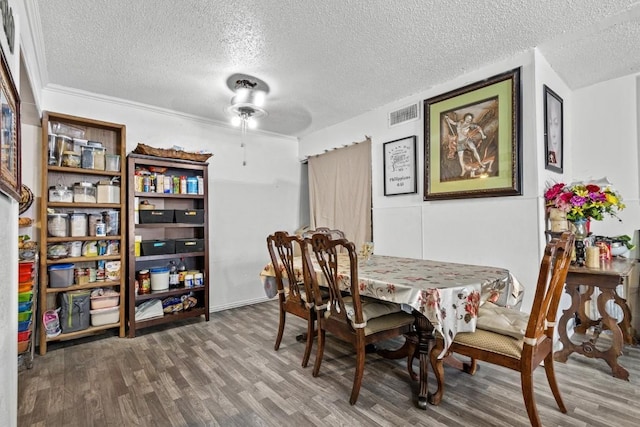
xmin=382 ymin=135 xmax=418 ymax=196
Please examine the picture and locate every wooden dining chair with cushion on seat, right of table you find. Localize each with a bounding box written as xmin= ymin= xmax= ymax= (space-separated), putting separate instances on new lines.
xmin=430 ymin=232 xmax=574 ymax=426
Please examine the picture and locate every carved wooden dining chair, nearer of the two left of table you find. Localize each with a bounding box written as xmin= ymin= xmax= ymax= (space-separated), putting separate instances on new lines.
xmin=302 ymin=233 xmax=414 ymax=405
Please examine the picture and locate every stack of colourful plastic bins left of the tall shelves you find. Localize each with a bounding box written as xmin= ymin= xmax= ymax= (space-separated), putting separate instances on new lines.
xmin=18 ymin=261 xmax=37 ymax=368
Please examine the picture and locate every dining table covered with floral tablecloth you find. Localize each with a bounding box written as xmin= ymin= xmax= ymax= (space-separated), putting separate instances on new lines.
xmin=260 ymin=254 xmax=524 ymax=409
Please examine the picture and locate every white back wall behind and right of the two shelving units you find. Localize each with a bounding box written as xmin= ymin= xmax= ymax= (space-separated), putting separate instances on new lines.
xmin=37 ymin=90 xmax=300 ymax=311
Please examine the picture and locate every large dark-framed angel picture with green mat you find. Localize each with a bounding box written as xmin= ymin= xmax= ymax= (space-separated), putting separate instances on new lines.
xmin=424 ymin=68 xmax=522 ymax=200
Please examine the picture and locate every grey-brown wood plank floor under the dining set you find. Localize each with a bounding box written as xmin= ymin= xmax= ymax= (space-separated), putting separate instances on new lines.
xmin=18 ymin=302 xmax=640 ymax=427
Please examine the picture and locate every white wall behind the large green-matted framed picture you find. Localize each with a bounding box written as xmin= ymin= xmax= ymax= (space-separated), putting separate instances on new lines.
xmin=300 ymin=52 xmax=544 ymax=310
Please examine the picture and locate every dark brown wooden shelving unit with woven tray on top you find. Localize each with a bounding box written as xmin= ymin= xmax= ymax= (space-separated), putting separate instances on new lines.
xmin=127 ymin=153 xmax=209 ymax=337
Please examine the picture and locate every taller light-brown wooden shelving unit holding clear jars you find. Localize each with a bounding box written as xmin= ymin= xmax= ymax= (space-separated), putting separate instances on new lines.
xmin=38 ymin=111 xmax=127 ymax=355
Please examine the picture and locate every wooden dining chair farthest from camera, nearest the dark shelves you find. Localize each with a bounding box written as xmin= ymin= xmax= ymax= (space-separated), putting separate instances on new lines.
xmin=267 ymin=231 xmax=316 ymax=367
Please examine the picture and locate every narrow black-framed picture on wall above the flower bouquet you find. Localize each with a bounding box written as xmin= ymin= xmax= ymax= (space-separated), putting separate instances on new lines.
xmin=544 ymin=85 xmax=564 ymax=173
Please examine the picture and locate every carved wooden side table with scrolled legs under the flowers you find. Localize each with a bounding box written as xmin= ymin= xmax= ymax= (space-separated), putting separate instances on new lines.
xmin=554 ymin=258 xmax=636 ymax=381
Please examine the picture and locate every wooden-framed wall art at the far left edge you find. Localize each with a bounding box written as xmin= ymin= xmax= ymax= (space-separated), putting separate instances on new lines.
xmin=0 ymin=43 xmax=21 ymax=202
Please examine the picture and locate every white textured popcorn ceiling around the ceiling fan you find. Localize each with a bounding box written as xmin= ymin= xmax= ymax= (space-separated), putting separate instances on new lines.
xmin=36 ymin=0 xmax=640 ymax=137
